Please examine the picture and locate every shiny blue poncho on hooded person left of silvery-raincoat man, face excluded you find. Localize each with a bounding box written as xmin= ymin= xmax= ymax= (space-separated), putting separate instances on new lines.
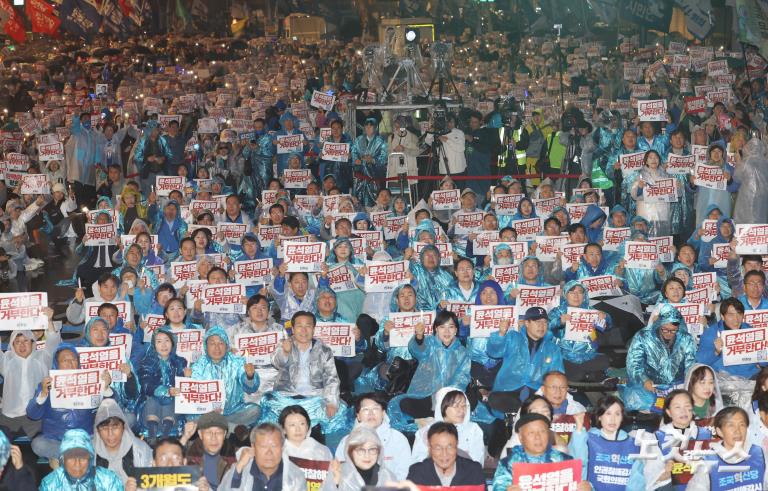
xmin=192 ymin=326 xmax=259 ymax=416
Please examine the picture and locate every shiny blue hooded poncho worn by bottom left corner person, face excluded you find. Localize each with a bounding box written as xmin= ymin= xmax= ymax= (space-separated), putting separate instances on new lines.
xmin=40 ymin=429 xmax=123 ymax=491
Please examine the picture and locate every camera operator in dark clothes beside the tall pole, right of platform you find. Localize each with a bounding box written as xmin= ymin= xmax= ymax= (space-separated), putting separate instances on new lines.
xmin=555 ymin=107 xmax=596 ymax=199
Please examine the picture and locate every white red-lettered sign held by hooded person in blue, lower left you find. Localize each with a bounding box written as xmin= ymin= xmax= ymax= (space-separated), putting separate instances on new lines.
xmin=48 ymin=368 xmax=103 ymax=409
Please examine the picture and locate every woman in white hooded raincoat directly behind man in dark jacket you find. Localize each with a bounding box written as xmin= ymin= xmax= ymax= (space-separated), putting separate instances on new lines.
xmin=411 ymin=387 xmax=485 ymax=465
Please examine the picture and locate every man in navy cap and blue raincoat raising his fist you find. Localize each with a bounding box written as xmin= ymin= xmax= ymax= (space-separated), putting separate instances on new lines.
xmin=487 ymin=307 xmax=564 ymax=413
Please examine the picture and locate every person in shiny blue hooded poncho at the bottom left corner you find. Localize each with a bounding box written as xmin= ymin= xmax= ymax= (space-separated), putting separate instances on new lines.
xmin=40 ymin=429 xmax=123 ymax=491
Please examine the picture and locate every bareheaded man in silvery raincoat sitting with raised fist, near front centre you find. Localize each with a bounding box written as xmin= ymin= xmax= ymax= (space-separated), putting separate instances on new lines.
xmin=261 ymin=310 xmax=341 ymax=436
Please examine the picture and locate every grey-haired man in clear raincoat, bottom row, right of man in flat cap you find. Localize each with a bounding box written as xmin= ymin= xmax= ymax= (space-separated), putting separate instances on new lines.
xmin=219 ymin=423 xmax=307 ymax=491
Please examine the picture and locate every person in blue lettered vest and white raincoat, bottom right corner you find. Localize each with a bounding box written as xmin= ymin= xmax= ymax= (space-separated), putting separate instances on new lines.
xmin=686 ymin=406 xmax=768 ymax=491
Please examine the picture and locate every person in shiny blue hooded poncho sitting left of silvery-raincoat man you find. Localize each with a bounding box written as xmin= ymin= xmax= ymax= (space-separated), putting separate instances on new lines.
xmin=184 ymin=326 xmax=260 ymax=428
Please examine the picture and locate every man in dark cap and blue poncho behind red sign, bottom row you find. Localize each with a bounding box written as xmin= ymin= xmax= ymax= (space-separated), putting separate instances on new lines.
xmin=492 ymin=412 xmax=593 ymax=491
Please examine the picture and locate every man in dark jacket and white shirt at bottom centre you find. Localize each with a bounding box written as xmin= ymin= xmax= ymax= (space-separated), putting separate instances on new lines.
xmin=408 ymin=421 xmax=485 ymax=486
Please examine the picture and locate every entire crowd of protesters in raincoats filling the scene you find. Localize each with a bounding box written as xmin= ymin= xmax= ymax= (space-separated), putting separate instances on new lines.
xmin=0 ymin=25 xmax=768 ymax=491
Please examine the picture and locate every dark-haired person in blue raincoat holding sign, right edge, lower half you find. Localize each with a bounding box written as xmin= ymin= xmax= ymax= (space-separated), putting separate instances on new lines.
xmin=696 ymin=298 xmax=766 ymax=379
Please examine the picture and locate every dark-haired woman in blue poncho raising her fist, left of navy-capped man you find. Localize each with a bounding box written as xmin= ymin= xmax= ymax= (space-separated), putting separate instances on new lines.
xmin=388 ymin=310 xmax=470 ymax=432
